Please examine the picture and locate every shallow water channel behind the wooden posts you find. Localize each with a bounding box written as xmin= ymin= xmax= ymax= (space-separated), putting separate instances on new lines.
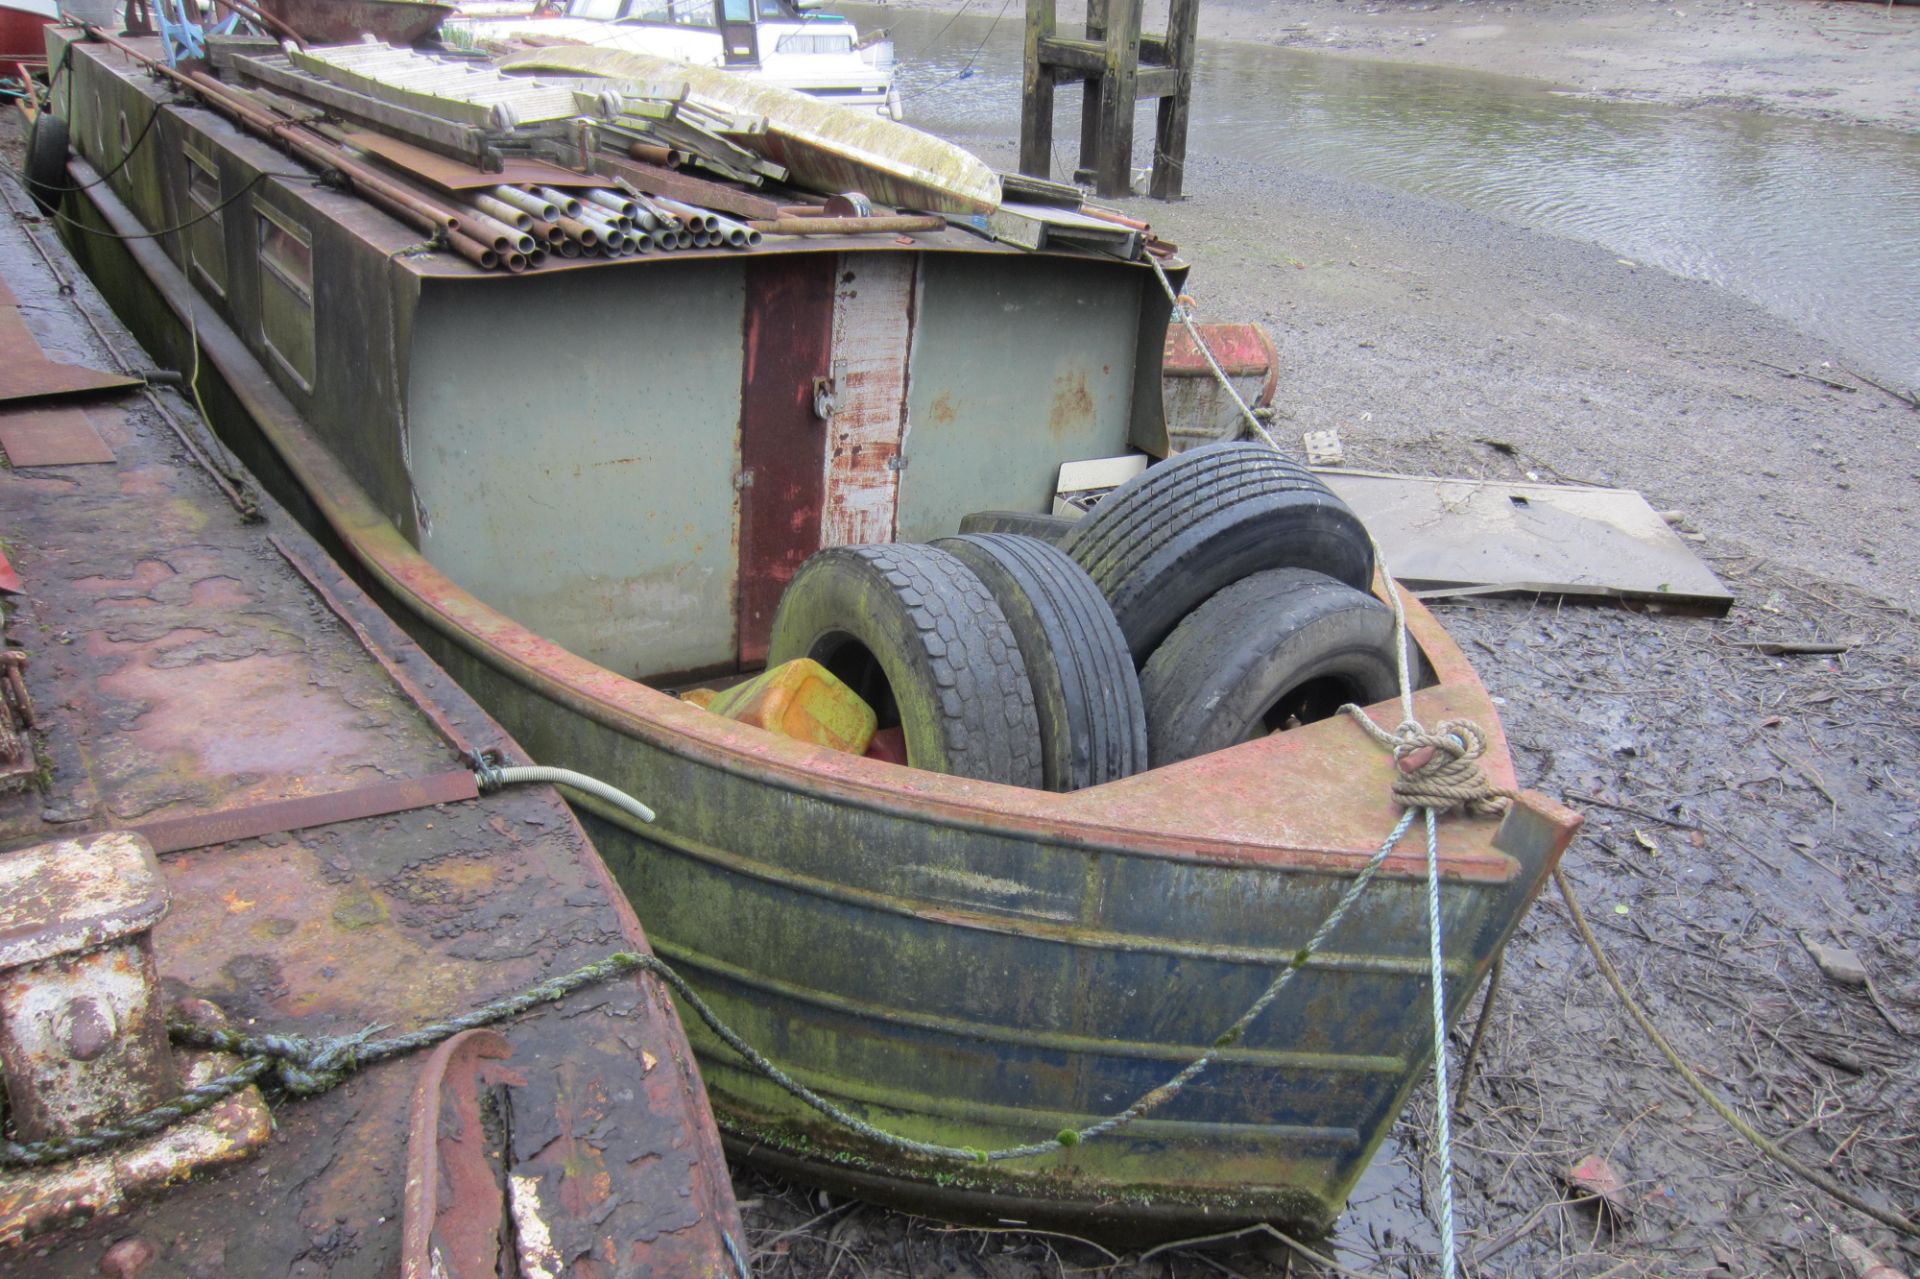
xmin=847 ymin=6 xmax=1920 ymax=386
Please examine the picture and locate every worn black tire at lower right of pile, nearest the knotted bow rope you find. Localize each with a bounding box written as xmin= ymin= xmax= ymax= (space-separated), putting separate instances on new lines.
xmin=1140 ymin=568 xmax=1400 ymax=768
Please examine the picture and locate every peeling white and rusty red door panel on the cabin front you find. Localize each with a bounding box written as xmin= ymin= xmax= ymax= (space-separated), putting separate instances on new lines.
xmin=820 ymin=253 xmax=918 ymax=545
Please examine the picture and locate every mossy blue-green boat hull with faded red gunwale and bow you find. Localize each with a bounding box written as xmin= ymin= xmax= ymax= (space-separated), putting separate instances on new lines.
xmin=48 ymin=32 xmax=1578 ymax=1237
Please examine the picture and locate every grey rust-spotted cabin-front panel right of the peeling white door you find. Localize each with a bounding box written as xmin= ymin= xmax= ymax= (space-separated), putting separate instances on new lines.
xmin=897 ymin=253 xmax=1142 ymax=542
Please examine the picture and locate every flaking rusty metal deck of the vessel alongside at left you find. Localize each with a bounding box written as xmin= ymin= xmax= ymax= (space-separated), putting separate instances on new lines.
xmin=0 ymin=184 xmax=741 ymax=1279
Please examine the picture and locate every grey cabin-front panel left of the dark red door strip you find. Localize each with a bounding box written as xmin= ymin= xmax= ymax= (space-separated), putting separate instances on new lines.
xmin=407 ymin=261 xmax=745 ymax=676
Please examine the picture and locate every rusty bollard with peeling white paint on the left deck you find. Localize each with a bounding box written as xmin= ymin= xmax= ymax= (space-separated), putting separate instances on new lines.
xmin=0 ymin=832 xmax=180 ymax=1141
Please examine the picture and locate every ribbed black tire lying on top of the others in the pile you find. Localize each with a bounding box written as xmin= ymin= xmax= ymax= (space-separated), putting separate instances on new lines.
xmin=1062 ymin=444 xmax=1373 ymax=664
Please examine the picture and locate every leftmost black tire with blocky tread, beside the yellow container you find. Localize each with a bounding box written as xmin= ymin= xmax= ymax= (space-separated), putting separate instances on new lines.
xmin=766 ymin=543 xmax=1041 ymax=787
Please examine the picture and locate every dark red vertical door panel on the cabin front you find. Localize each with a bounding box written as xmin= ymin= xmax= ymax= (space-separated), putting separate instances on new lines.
xmin=735 ymin=253 xmax=839 ymax=666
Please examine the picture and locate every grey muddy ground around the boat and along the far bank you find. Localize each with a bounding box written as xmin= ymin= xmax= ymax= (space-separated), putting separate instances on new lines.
xmin=3 ymin=0 xmax=1920 ymax=1279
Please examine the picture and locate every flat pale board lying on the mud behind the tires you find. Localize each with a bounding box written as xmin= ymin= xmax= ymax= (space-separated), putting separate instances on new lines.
xmin=1319 ymin=471 xmax=1734 ymax=613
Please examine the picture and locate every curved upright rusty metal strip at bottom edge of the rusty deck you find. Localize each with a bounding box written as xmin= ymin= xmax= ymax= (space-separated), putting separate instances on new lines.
xmin=399 ymin=1029 xmax=524 ymax=1279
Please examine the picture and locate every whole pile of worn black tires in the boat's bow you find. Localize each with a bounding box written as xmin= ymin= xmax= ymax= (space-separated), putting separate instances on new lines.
xmin=768 ymin=444 xmax=1396 ymax=791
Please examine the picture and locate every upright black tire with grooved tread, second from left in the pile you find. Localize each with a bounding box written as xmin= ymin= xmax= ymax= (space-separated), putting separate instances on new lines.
xmin=933 ymin=534 xmax=1146 ymax=791
